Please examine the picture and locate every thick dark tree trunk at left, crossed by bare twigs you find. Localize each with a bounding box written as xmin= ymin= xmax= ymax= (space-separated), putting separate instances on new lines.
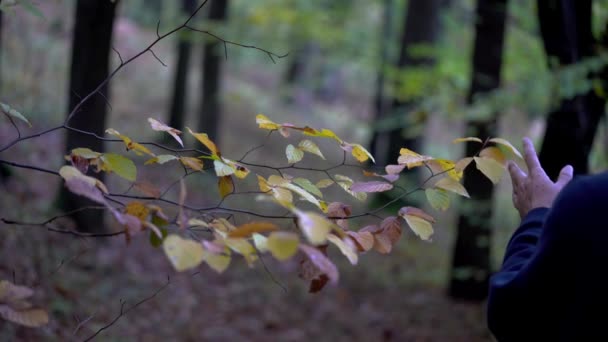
xmin=61 ymin=0 xmax=118 ymax=231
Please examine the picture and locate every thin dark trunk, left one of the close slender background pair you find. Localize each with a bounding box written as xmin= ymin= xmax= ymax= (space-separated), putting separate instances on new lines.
xmin=169 ymin=0 xmax=196 ymax=130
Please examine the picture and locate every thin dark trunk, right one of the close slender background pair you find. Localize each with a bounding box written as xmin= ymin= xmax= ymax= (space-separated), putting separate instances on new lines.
xmin=198 ymin=0 xmax=228 ymax=140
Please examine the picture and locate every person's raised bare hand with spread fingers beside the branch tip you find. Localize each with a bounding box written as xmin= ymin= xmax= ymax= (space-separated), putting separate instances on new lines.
xmin=508 ymin=138 xmax=574 ymax=218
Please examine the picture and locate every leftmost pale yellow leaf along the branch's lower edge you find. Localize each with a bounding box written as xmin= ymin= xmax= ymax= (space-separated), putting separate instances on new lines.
xmin=163 ymin=234 xmax=204 ymax=272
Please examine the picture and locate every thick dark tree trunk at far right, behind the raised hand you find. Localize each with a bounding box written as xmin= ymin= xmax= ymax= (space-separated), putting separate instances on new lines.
xmin=538 ymin=0 xmax=606 ymax=179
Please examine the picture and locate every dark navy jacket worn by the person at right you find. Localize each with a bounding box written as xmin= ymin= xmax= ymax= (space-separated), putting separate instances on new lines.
xmin=488 ymin=172 xmax=608 ymax=341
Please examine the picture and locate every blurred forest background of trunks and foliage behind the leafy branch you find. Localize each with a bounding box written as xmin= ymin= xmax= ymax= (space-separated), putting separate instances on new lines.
xmin=0 ymin=0 xmax=608 ymax=341
